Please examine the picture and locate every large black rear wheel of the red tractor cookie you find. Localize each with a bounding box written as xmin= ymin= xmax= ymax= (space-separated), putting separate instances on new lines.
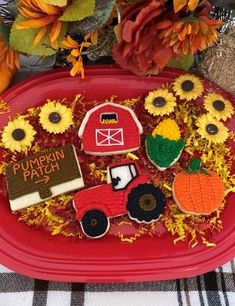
xmin=127 ymin=184 xmax=166 ymax=223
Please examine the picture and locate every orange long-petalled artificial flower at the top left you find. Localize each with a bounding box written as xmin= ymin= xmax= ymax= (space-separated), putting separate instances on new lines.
xmin=16 ymin=0 xmax=63 ymax=49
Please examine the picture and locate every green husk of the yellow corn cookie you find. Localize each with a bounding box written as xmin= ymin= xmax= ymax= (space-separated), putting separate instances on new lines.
xmin=146 ymin=135 xmax=184 ymax=168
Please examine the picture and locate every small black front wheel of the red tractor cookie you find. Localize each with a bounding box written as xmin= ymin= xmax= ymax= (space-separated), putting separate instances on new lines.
xmin=81 ymin=210 xmax=110 ymax=238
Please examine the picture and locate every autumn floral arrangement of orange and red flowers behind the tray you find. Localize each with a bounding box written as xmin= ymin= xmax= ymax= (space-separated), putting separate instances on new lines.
xmin=0 ymin=0 xmax=229 ymax=92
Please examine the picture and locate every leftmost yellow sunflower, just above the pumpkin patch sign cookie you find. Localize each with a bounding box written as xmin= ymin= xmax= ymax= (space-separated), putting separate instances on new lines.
xmin=2 ymin=118 xmax=36 ymax=152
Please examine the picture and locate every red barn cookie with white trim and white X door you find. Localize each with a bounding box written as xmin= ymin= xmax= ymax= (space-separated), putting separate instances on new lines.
xmin=78 ymin=102 xmax=143 ymax=155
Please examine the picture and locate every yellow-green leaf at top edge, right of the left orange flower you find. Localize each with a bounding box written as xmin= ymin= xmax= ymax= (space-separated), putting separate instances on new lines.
xmin=60 ymin=0 xmax=95 ymax=21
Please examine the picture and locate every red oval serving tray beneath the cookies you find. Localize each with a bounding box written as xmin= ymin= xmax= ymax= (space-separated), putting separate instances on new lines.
xmin=0 ymin=67 xmax=235 ymax=282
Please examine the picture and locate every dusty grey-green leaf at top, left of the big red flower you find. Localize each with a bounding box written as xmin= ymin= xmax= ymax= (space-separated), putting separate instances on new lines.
xmin=72 ymin=0 xmax=115 ymax=34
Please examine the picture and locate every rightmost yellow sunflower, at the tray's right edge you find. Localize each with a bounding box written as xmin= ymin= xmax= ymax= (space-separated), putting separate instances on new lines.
xmin=204 ymin=92 xmax=234 ymax=120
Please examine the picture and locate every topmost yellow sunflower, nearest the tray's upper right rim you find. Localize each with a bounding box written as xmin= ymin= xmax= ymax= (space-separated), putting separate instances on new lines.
xmin=173 ymin=73 xmax=204 ymax=101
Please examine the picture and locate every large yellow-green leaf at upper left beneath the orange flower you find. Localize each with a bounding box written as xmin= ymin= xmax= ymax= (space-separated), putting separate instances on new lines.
xmin=10 ymin=15 xmax=67 ymax=56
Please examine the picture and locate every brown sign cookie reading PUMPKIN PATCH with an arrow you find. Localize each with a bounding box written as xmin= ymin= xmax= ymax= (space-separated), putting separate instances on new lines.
xmin=6 ymin=145 xmax=84 ymax=211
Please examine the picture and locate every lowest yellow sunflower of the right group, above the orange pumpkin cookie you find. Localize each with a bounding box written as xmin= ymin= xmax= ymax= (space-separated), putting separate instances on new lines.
xmin=196 ymin=114 xmax=229 ymax=143
